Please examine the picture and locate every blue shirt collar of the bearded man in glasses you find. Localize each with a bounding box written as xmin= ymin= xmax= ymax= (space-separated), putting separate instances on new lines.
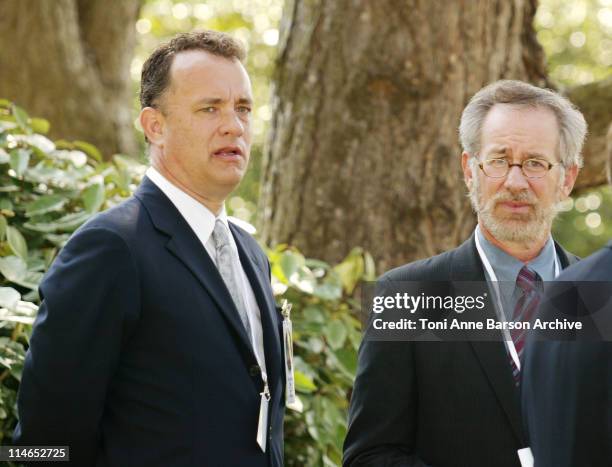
xmin=476 ymin=225 xmax=557 ymax=283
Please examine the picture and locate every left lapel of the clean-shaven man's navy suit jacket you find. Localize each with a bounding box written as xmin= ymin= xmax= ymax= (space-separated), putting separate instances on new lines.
xmin=135 ymin=177 xmax=255 ymax=362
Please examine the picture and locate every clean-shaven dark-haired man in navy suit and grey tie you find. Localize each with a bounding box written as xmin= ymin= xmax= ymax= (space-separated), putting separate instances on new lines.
xmin=15 ymin=31 xmax=284 ymax=467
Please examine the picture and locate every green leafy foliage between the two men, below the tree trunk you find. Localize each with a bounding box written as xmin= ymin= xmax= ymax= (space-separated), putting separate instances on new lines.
xmin=268 ymin=245 xmax=374 ymax=466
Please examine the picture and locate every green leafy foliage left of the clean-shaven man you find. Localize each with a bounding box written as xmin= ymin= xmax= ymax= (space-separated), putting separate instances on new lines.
xmin=0 ymin=100 xmax=144 ymax=443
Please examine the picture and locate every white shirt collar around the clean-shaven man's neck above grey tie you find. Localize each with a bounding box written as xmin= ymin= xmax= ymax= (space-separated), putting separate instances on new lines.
xmin=145 ymin=167 xmax=229 ymax=244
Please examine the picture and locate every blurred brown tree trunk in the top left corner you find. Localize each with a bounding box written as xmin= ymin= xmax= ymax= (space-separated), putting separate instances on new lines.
xmin=0 ymin=0 xmax=141 ymax=157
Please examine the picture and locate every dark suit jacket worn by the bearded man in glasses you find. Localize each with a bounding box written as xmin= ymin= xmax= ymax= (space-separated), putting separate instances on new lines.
xmin=344 ymin=235 xmax=574 ymax=467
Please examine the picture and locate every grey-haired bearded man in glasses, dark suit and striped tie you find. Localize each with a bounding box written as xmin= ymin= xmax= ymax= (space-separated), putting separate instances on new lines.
xmin=344 ymin=81 xmax=586 ymax=467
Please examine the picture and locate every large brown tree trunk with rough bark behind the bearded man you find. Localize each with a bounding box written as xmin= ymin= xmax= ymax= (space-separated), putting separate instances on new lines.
xmin=259 ymin=0 xmax=548 ymax=270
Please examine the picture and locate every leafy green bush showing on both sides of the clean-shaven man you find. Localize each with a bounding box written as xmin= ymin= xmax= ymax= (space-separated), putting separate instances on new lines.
xmin=0 ymin=100 xmax=374 ymax=466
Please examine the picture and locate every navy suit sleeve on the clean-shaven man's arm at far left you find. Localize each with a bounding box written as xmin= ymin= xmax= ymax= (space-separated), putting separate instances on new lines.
xmin=15 ymin=227 xmax=140 ymax=465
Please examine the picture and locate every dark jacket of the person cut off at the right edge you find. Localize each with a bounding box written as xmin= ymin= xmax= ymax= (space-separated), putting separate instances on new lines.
xmin=522 ymin=242 xmax=612 ymax=467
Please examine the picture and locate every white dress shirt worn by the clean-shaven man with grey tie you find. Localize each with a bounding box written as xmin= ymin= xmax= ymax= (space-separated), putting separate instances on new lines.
xmin=145 ymin=167 xmax=266 ymax=379
